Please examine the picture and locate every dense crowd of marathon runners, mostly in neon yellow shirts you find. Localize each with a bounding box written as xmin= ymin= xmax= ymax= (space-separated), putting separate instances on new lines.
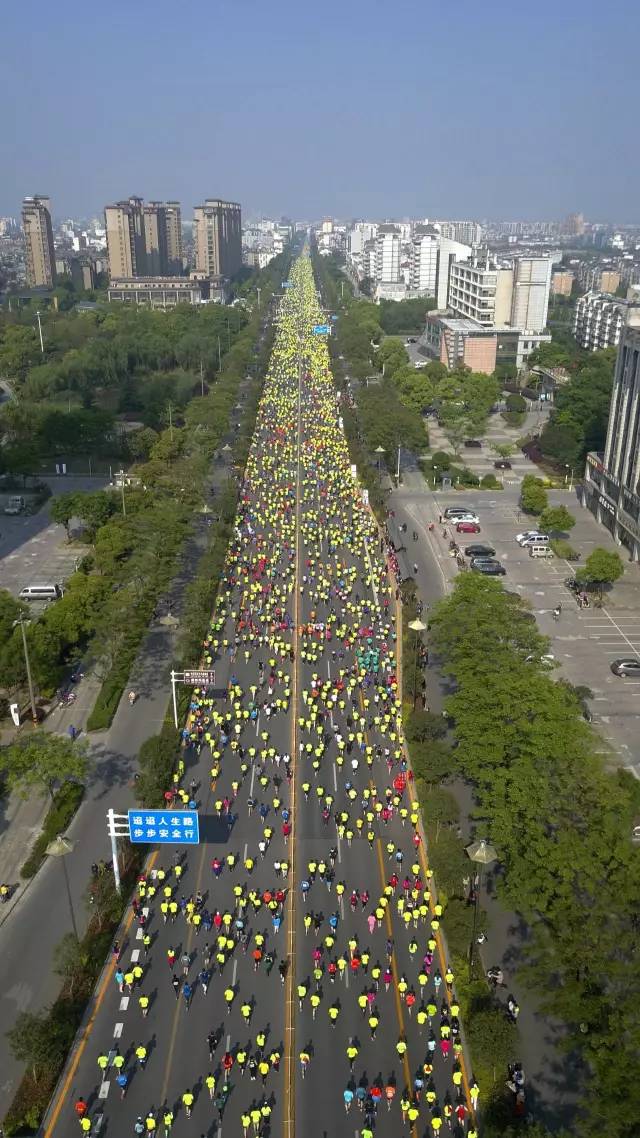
xmin=62 ymin=256 xmax=478 ymax=1138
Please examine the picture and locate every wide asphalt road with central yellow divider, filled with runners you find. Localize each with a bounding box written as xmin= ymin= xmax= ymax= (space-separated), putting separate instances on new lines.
xmin=43 ymin=257 xmax=467 ymax=1138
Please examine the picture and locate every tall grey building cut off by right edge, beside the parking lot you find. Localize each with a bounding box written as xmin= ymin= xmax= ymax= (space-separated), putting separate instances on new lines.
xmin=582 ymin=307 xmax=640 ymax=561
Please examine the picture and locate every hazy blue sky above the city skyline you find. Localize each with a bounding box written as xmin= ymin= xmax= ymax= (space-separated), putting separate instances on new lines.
xmin=0 ymin=0 xmax=640 ymax=222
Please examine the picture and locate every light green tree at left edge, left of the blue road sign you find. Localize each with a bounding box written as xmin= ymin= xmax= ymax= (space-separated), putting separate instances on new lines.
xmin=0 ymin=731 xmax=88 ymax=798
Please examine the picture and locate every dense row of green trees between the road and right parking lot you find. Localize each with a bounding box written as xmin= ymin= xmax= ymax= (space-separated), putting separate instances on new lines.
xmin=423 ymin=574 xmax=640 ymax=1138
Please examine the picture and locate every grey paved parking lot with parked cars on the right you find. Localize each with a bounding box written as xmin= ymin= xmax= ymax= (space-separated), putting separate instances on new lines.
xmin=392 ymin=489 xmax=640 ymax=777
